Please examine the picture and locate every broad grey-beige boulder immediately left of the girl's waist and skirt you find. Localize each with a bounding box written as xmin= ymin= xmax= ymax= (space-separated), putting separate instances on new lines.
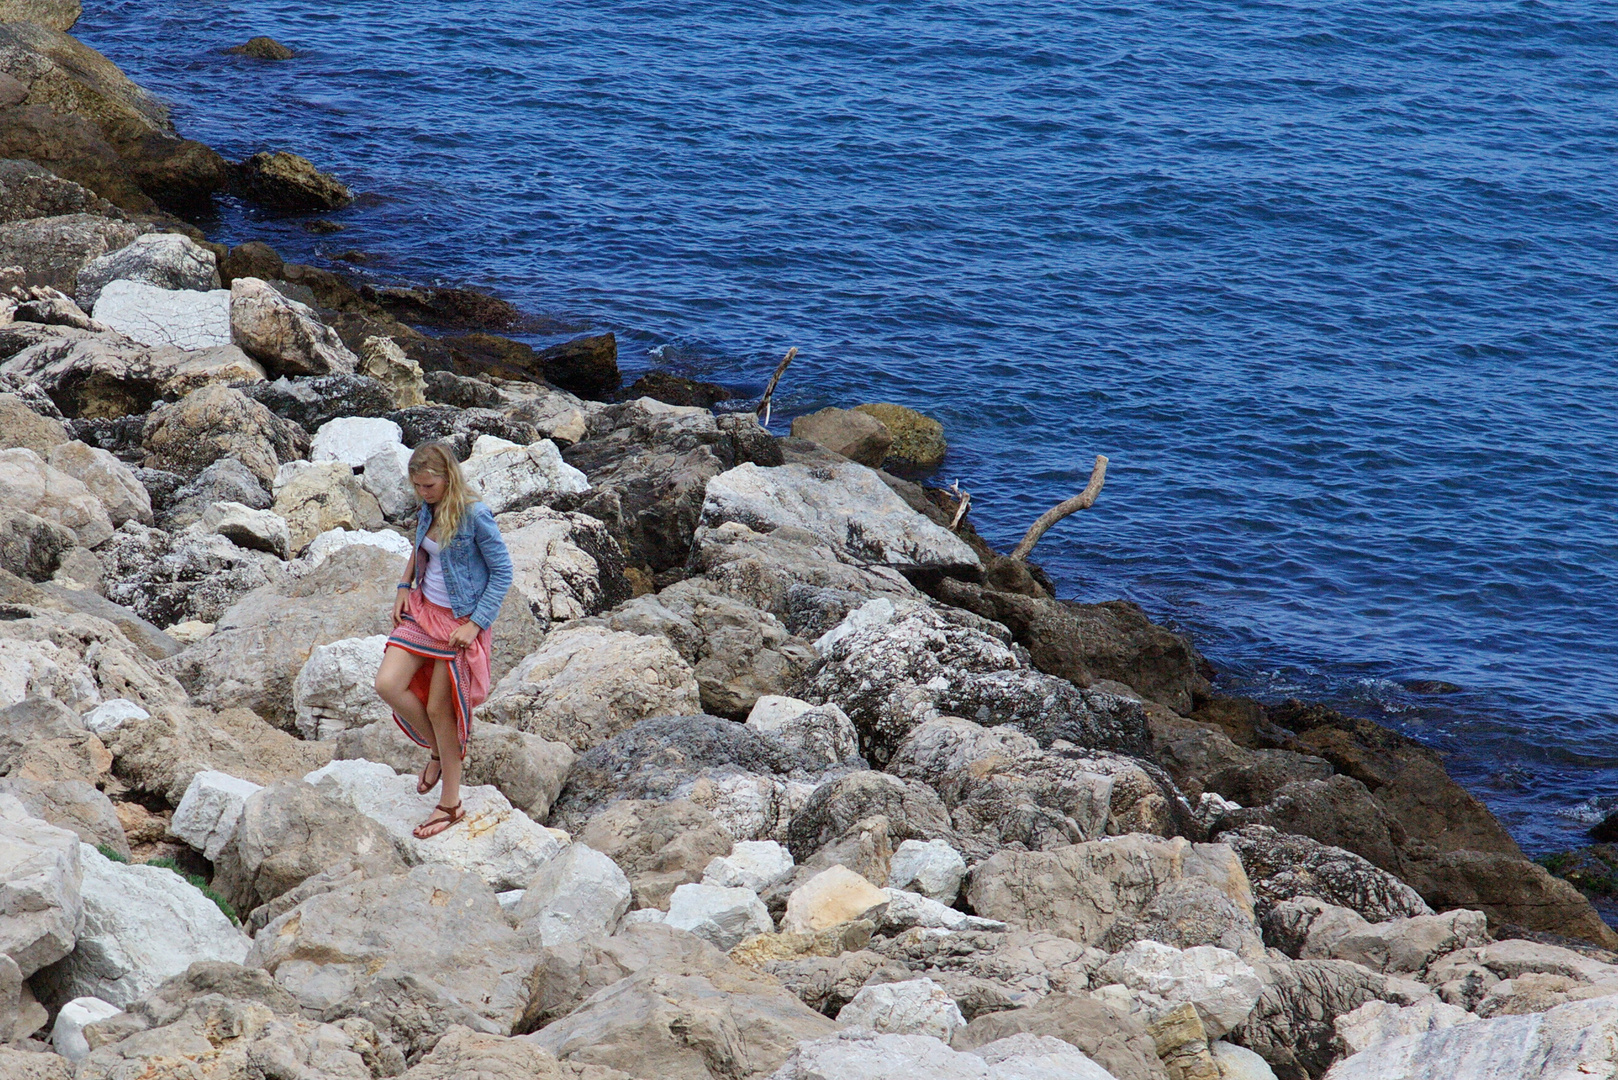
xmin=167 ymin=544 xmax=405 ymax=727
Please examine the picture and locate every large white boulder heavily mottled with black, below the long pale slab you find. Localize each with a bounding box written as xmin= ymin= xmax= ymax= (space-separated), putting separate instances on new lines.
xmin=801 ymin=599 xmax=1150 ymax=764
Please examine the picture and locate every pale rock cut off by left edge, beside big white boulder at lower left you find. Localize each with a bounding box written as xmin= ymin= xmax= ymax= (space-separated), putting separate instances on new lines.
xmin=0 ymin=795 xmax=82 ymax=978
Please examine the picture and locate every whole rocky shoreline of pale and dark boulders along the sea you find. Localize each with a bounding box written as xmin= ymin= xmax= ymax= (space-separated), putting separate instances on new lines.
xmin=0 ymin=0 xmax=1618 ymax=1080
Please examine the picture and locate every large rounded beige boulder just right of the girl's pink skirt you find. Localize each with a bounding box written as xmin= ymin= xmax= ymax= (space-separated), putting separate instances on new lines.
xmin=484 ymin=625 xmax=701 ymax=751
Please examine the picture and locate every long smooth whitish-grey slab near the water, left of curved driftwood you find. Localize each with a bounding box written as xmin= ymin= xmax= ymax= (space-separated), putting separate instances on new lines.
xmin=701 ymin=461 xmax=982 ymax=570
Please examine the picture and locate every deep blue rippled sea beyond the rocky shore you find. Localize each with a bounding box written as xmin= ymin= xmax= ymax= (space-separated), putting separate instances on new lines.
xmin=74 ymin=0 xmax=1618 ymax=852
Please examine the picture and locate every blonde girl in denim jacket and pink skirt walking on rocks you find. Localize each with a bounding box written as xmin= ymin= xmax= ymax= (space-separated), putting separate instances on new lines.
xmin=377 ymin=442 xmax=511 ymax=840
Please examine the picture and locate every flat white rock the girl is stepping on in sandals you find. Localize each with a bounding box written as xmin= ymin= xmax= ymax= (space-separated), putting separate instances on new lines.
xmin=304 ymin=759 xmax=561 ymax=891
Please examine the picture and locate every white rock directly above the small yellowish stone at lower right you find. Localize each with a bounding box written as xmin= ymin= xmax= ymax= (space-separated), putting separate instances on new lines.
xmin=1095 ymin=941 xmax=1264 ymax=1038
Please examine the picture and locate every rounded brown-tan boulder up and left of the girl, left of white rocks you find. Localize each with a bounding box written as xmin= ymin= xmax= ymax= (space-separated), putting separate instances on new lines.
xmin=141 ymin=385 xmax=309 ymax=484
